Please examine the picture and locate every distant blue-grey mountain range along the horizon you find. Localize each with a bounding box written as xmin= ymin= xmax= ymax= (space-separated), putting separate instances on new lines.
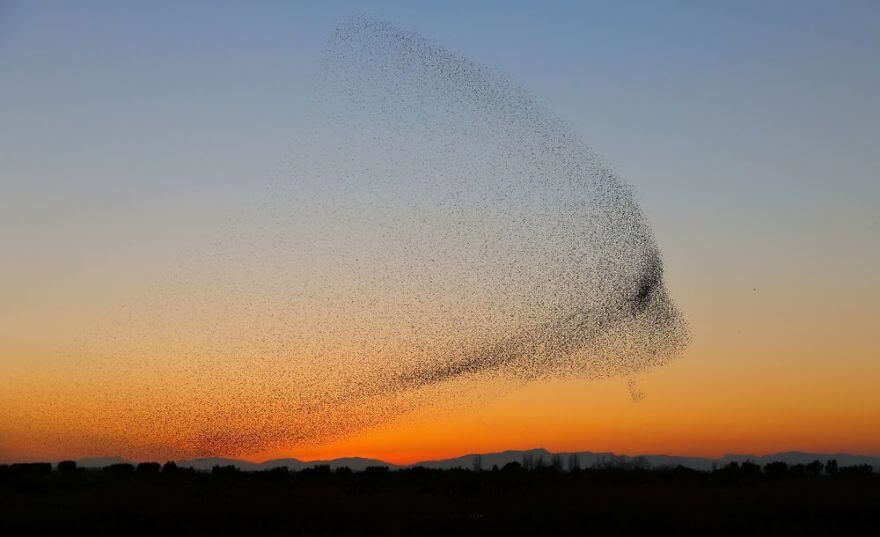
xmin=77 ymin=448 xmax=880 ymax=472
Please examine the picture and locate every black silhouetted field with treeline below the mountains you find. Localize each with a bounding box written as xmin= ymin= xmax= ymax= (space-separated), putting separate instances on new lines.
xmin=0 ymin=463 xmax=880 ymax=535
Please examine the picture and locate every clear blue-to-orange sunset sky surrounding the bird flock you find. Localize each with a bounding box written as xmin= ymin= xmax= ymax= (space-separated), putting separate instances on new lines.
xmin=0 ymin=1 xmax=880 ymax=462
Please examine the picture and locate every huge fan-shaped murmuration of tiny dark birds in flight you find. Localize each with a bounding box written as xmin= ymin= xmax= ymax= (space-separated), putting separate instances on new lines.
xmin=53 ymin=18 xmax=688 ymax=456
